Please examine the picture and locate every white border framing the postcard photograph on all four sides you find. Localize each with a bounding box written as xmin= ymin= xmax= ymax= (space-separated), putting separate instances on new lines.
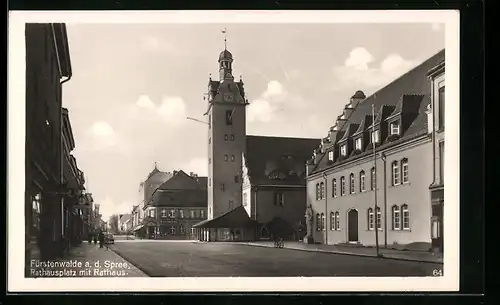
xmin=7 ymin=10 xmax=460 ymax=292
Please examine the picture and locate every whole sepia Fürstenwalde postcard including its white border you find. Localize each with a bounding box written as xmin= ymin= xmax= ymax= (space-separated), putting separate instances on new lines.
xmin=8 ymin=11 xmax=460 ymax=291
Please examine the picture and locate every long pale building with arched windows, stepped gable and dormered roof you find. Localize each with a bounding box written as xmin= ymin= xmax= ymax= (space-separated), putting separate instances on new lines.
xmin=307 ymin=50 xmax=444 ymax=249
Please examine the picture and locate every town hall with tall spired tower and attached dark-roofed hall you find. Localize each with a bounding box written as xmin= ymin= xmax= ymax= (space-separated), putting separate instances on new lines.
xmin=191 ymin=45 xmax=320 ymax=241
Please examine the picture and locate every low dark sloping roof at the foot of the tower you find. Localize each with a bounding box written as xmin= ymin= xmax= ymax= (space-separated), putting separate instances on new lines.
xmin=193 ymin=206 xmax=258 ymax=228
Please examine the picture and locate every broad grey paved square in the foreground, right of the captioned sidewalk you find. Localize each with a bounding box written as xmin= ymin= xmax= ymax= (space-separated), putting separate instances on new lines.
xmin=111 ymin=241 xmax=442 ymax=277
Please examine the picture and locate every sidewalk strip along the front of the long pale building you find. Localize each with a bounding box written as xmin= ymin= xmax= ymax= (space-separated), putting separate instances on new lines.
xmin=233 ymin=241 xmax=443 ymax=264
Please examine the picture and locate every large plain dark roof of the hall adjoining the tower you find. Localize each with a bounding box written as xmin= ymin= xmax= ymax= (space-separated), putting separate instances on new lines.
xmin=245 ymin=136 xmax=321 ymax=185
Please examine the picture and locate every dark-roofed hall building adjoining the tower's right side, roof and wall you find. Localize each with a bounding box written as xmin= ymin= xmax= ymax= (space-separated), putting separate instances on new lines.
xmin=242 ymin=136 xmax=321 ymax=240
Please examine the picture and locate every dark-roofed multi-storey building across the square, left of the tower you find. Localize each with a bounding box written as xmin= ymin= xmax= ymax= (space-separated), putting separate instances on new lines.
xmin=141 ymin=170 xmax=207 ymax=239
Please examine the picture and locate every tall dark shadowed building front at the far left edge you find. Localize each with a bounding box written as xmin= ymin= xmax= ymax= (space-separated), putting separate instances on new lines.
xmin=25 ymin=23 xmax=72 ymax=269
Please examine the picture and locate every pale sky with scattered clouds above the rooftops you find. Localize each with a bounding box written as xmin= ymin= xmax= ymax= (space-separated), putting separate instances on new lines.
xmin=63 ymin=23 xmax=445 ymax=220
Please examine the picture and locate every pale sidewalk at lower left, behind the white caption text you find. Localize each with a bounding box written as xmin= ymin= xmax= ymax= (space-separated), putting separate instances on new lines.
xmin=31 ymin=242 xmax=147 ymax=277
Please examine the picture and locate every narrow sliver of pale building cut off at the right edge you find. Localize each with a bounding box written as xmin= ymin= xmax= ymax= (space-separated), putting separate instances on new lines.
xmin=427 ymin=61 xmax=445 ymax=252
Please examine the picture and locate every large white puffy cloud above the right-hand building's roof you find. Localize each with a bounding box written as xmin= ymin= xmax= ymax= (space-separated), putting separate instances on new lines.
xmin=333 ymin=48 xmax=418 ymax=92
